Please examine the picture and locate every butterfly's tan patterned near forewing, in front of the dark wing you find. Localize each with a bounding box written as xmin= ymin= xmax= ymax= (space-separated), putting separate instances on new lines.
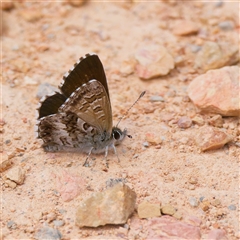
xmin=59 ymin=80 xmax=112 ymax=134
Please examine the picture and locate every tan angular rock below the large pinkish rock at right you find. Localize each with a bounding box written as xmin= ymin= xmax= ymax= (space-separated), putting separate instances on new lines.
xmin=196 ymin=127 xmax=233 ymax=151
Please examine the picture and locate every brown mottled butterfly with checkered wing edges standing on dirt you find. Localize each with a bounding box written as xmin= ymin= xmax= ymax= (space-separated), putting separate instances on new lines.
xmin=36 ymin=53 xmax=139 ymax=163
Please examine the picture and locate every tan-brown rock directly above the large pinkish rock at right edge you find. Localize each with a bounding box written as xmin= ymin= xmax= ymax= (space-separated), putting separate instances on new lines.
xmin=194 ymin=42 xmax=239 ymax=72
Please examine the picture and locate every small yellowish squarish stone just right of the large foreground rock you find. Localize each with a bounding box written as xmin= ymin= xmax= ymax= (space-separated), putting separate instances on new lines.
xmin=138 ymin=202 xmax=161 ymax=218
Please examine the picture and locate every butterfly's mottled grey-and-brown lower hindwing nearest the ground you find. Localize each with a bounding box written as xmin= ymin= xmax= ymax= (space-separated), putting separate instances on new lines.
xmin=37 ymin=113 xmax=97 ymax=152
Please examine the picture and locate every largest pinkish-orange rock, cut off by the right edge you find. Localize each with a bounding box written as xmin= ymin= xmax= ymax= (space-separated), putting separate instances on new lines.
xmin=188 ymin=66 xmax=240 ymax=116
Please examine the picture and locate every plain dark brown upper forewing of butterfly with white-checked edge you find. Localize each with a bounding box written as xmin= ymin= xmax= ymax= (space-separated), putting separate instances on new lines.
xmin=59 ymin=53 xmax=110 ymax=99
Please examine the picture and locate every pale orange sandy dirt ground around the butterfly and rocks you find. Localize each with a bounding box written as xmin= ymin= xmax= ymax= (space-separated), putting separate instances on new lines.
xmin=0 ymin=1 xmax=240 ymax=239
